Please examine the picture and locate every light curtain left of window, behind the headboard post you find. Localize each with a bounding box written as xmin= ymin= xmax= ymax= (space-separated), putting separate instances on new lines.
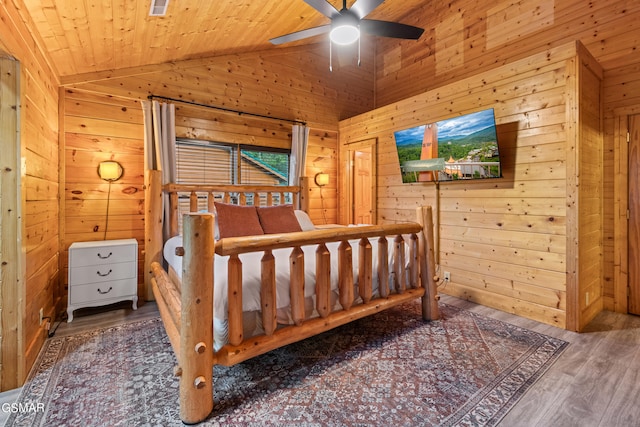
xmin=141 ymin=101 xmax=176 ymax=238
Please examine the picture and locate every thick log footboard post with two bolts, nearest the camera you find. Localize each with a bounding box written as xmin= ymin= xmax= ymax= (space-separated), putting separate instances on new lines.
xmin=180 ymin=213 xmax=215 ymax=424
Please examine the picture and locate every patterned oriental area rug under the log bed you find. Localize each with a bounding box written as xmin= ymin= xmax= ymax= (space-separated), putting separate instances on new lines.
xmin=6 ymin=302 xmax=567 ymax=426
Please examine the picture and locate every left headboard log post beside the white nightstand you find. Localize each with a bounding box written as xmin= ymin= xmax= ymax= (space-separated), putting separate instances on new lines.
xmin=145 ymin=170 xmax=164 ymax=301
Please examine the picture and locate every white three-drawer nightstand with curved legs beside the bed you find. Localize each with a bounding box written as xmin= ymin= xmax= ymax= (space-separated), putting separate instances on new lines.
xmin=67 ymin=239 xmax=138 ymax=322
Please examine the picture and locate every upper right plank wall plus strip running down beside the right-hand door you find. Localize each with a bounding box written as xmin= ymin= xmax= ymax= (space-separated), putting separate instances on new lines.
xmin=375 ymin=0 xmax=640 ymax=312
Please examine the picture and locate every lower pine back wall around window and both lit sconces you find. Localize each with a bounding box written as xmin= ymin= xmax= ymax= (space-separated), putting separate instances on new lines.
xmin=61 ymin=89 xmax=338 ymax=298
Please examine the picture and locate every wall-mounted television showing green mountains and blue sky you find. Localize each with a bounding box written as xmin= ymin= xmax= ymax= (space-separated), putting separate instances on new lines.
xmin=394 ymin=108 xmax=502 ymax=183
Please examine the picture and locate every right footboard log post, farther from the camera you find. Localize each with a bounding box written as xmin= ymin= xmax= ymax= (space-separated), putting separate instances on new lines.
xmin=416 ymin=206 xmax=440 ymax=320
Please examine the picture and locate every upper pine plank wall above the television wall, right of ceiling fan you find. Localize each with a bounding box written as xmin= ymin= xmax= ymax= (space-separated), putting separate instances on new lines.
xmin=375 ymin=0 xmax=640 ymax=107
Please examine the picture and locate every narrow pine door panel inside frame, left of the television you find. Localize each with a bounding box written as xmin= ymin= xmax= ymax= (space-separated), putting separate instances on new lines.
xmin=353 ymin=147 xmax=375 ymax=224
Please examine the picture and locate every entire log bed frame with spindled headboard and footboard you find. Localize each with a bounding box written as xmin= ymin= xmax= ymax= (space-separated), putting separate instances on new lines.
xmin=145 ymin=171 xmax=439 ymax=424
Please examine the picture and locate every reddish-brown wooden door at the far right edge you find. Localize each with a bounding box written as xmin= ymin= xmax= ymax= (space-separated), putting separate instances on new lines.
xmin=627 ymin=114 xmax=640 ymax=314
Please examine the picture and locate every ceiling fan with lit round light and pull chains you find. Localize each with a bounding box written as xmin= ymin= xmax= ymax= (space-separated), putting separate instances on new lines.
xmin=269 ymin=0 xmax=424 ymax=68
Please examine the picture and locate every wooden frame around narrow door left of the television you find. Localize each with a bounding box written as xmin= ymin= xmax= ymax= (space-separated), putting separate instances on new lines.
xmin=338 ymin=138 xmax=378 ymax=224
